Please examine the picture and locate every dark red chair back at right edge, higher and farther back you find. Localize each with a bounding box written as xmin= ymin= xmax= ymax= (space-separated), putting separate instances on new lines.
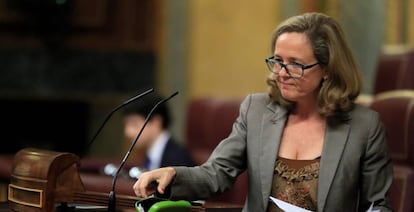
xmin=373 ymin=50 xmax=414 ymax=94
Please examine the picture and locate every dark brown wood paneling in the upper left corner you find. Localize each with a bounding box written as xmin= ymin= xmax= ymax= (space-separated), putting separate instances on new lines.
xmin=0 ymin=0 xmax=159 ymax=51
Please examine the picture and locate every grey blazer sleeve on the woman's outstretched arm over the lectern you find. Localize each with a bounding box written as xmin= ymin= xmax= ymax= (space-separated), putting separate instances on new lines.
xmin=167 ymin=97 xmax=251 ymax=200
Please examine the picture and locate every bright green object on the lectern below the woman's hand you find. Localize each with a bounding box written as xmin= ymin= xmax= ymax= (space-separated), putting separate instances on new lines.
xmin=135 ymin=200 xmax=191 ymax=212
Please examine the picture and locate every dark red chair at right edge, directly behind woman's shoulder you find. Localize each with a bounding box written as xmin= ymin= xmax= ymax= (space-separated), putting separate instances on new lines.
xmin=370 ymin=90 xmax=414 ymax=212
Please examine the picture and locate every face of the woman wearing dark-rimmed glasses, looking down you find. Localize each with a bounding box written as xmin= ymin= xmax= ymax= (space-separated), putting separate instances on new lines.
xmin=273 ymin=32 xmax=324 ymax=102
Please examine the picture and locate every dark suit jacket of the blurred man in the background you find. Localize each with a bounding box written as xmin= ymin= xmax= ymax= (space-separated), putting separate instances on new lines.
xmin=160 ymin=138 xmax=194 ymax=167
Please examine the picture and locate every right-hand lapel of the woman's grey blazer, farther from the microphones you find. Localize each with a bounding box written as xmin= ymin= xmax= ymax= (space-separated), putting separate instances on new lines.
xmin=318 ymin=117 xmax=350 ymax=211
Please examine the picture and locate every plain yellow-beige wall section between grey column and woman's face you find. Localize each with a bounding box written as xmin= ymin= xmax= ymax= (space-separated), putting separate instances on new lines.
xmin=187 ymin=0 xmax=278 ymax=98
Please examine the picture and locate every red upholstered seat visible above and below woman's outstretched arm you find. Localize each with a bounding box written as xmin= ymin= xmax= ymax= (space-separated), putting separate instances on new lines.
xmin=186 ymin=97 xmax=247 ymax=204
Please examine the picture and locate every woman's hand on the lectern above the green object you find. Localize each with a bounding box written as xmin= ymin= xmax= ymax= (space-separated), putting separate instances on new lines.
xmin=133 ymin=167 xmax=176 ymax=198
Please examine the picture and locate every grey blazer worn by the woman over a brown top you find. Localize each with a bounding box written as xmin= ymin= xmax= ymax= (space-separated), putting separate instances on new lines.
xmin=171 ymin=93 xmax=393 ymax=212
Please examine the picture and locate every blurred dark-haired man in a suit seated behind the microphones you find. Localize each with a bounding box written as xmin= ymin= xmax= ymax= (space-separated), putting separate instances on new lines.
xmin=119 ymin=94 xmax=194 ymax=178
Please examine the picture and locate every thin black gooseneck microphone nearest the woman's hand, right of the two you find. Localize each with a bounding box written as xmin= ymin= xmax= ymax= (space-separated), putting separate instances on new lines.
xmin=108 ymin=91 xmax=178 ymax=212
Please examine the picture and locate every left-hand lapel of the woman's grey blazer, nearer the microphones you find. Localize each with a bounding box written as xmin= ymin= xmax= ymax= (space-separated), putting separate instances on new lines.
xmin=259 ymin=103 xmax=287 ymax=209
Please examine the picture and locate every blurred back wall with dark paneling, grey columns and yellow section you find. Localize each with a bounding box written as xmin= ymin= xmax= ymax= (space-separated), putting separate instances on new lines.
xmin=0 ymin=0 xmax=414 ymax=156
